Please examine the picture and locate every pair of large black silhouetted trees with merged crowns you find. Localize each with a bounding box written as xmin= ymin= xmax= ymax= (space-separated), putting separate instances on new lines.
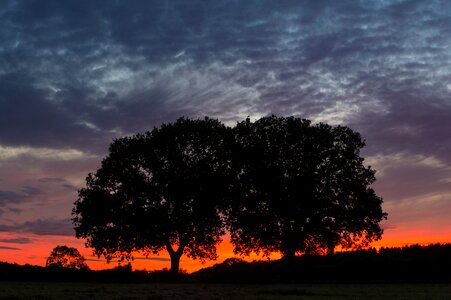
xmin=73 ymin=116 xmax=387 ymax=273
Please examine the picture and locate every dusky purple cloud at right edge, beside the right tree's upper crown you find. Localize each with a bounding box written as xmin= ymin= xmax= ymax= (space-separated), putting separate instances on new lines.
xmin=352 ymin=95 xmax=451 ymax=164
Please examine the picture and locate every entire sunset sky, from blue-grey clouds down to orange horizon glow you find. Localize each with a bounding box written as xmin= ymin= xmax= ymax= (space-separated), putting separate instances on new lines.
xmin=0 ymin=0 xmax=451 ymax=271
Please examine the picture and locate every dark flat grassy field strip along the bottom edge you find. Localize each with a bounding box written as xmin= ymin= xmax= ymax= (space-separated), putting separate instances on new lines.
xmin=0 ymin=282 xmax=451 ymax=300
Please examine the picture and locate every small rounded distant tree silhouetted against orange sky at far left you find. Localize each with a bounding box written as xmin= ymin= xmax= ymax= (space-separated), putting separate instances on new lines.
xmin=45 ymin=246 xmax=89 ymax=270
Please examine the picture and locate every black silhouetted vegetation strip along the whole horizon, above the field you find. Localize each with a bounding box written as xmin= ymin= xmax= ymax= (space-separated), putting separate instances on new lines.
xmin=0 ymin=244 xmax=451 ymax=284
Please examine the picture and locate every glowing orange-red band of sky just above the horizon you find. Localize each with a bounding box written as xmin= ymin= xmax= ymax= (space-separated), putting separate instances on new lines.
xmin=0 ymin=221 xmax=451 ymax=272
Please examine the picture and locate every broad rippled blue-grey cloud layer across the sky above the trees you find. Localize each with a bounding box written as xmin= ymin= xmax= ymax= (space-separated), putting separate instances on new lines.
xmin=0 ymin=1 xmax=451 ymax=151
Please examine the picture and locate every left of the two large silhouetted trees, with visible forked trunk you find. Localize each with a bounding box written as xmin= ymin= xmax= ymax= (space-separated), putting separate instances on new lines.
xmin=73 ymin=118 xmax=230 ymax=272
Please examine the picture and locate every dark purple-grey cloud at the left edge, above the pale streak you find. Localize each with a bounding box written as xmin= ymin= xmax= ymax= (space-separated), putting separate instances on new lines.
xmin=0 ymin=76 xmax=114 ymax=154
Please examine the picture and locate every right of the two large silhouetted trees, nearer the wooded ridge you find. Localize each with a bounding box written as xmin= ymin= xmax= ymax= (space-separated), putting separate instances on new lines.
xmin=228 ymin=116 xmax=386 ymax=258
